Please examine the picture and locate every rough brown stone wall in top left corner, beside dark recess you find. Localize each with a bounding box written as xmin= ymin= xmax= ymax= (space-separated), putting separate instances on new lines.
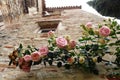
xmin=1 ymin=0 xmax=23 ymax=24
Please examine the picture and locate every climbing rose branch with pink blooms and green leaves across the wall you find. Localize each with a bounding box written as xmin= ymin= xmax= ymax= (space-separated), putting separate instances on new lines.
xmin=9 ymin=19 xmax=120 ymax=79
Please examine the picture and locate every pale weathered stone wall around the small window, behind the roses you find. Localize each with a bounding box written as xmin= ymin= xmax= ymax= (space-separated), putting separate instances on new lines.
xmin=0 ymin=9 xmax=108 ymax=80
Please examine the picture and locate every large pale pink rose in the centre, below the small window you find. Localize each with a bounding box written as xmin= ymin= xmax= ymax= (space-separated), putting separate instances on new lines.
xmin=56 ymin=37 xmax=68 ymax=48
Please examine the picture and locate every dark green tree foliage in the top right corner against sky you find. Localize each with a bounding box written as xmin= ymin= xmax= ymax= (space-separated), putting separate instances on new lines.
xmin=88 ymin=0 xmax=120 ymax=19
